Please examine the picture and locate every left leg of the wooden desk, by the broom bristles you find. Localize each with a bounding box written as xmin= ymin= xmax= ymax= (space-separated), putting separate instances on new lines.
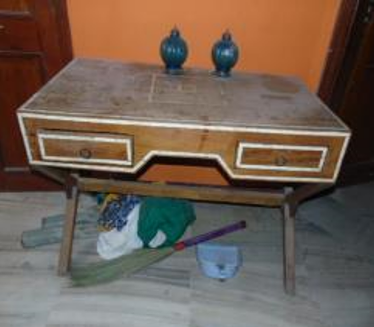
xmin=58 ymin=178 xmax=79 ymax=276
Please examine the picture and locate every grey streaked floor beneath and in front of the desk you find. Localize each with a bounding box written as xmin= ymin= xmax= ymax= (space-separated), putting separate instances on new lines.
xmin=0 ymin=183 xmax=374 ymax=327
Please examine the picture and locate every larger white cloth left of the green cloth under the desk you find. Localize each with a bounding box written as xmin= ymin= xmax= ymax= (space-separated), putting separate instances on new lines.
xmin=97 ymin=204 xmax=143 ymax=260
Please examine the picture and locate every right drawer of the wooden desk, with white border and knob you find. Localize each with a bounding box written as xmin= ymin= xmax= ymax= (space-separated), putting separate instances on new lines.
xmin=236 ymin=142 xmax=327 ymax=172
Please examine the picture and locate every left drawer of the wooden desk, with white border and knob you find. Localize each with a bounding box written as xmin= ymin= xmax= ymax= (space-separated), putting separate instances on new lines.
xmin=37 ymin=131 xmax=133 ymax=166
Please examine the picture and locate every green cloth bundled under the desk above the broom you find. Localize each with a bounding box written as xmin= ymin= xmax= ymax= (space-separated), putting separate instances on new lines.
xmin=138 ymin=197 xmax=196 ymax=247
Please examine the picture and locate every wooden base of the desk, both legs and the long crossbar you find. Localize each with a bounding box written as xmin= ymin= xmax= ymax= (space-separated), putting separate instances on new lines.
xmin=34 ymin=167 xmax=332 ymax=295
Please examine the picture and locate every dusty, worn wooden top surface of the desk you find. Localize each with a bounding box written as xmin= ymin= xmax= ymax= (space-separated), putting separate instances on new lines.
xmin=20 ymin=59 xmax=348 ymax=132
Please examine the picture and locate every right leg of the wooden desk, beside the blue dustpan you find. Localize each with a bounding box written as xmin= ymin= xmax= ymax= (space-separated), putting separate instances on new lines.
xmin=283 ymin=190 xmax=296 ymax=295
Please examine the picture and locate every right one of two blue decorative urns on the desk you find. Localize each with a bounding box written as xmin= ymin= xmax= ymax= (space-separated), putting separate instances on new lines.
xmin=212 ymin=31 xmax=239 ymax=77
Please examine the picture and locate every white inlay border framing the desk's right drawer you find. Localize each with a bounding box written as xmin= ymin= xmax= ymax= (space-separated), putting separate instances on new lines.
xmin=235 ymin=142 xmax=327 ymax=172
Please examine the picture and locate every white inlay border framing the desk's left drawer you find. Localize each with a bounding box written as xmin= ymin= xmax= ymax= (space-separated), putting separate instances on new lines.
xmin=38 ymin=132 xmax=133 ymax=166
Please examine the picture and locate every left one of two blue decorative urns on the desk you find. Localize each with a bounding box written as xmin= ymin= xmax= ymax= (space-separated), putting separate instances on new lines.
xmin=160 ymin=27 xmax=188 ymax=75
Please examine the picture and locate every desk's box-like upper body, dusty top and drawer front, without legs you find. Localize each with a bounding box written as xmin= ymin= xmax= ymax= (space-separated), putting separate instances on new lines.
xmin=19 ymin=59 xmax=349 ymax=182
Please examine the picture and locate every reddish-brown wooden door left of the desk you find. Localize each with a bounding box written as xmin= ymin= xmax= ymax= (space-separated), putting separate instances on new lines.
xmin=0 ymin=0 xmax=72 ymax=191
